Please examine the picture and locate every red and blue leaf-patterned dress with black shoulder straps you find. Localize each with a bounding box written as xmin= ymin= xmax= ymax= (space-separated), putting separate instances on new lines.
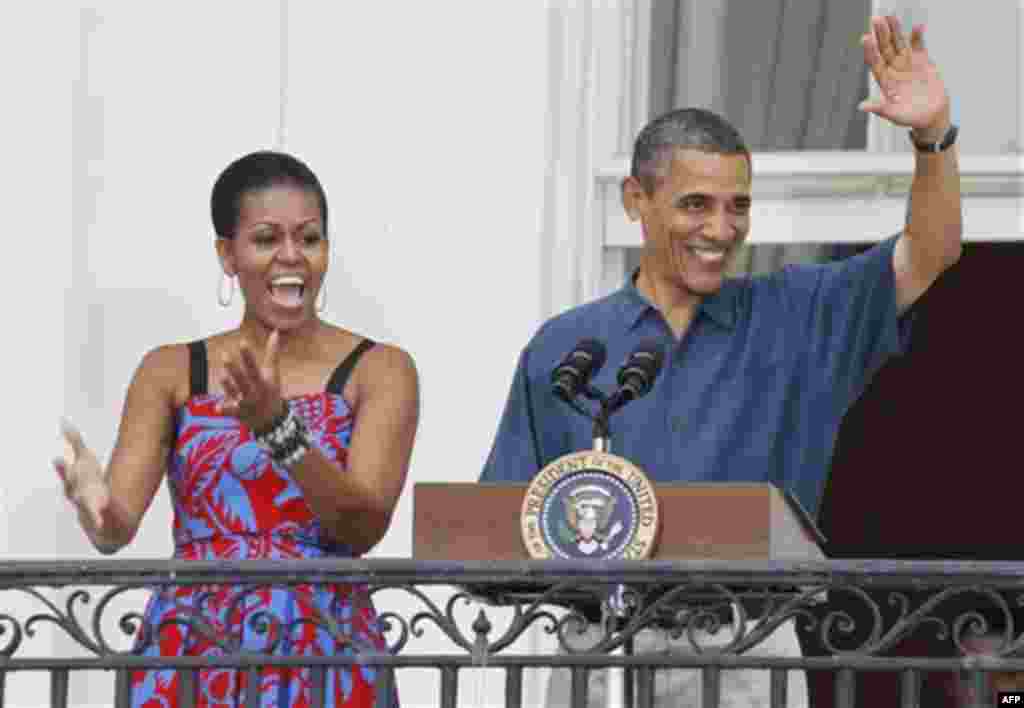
xmin=131 ymin=340 xmax=397 ymax=708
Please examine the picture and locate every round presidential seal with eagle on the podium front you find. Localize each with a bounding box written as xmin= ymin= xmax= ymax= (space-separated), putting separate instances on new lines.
xmin=520 ymin=450 xmax=658 ymax=559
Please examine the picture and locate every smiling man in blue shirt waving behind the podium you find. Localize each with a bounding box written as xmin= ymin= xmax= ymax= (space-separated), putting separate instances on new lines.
xmin=481 ymin=12 xmax=962 ymax=705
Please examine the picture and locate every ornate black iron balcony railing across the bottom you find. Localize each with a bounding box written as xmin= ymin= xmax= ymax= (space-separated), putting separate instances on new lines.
xmin=0 ymin=559 xmax=1024 ymax=708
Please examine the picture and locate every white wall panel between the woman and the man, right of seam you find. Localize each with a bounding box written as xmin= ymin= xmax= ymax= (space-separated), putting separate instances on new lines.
xmin=286 ymin=1 xmax=546 ymax=556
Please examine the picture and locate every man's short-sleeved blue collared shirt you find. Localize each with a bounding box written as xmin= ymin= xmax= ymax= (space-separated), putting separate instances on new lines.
xmin=480 ymin=237 xmax=910 ymax=517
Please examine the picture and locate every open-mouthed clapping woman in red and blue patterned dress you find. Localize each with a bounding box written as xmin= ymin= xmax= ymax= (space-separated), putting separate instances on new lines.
xmin=54 ymin=152 xmax=419 ymax=708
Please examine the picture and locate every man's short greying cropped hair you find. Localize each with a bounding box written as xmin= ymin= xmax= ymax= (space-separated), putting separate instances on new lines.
xmin=630 ymin=108 xmax=751 ymax=195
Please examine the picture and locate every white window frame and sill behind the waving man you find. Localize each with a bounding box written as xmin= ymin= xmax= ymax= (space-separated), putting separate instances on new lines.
xmin=543 ymin=0 xmax=1024 ymax=309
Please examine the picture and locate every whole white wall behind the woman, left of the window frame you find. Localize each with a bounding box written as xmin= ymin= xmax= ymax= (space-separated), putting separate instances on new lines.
xmin=0 ymin=0 xmax=547 ymax=706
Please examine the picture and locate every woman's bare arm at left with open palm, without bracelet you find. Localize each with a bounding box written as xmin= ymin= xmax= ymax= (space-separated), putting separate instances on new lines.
xmin=54 ymin=346 xmax=179 ymax=554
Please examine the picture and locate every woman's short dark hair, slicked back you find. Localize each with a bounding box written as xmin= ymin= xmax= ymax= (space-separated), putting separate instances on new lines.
xmin=210 ymin=150 xmax=327 ymax=239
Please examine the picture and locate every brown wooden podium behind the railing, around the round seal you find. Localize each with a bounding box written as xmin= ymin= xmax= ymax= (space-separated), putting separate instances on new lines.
xmin=413 ymin=483 xmax=824 ymax=560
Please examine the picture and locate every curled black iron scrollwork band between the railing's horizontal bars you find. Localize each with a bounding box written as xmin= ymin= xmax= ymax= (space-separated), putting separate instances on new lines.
xmin=0 ymin=571 xmax=1024 ymax=665
